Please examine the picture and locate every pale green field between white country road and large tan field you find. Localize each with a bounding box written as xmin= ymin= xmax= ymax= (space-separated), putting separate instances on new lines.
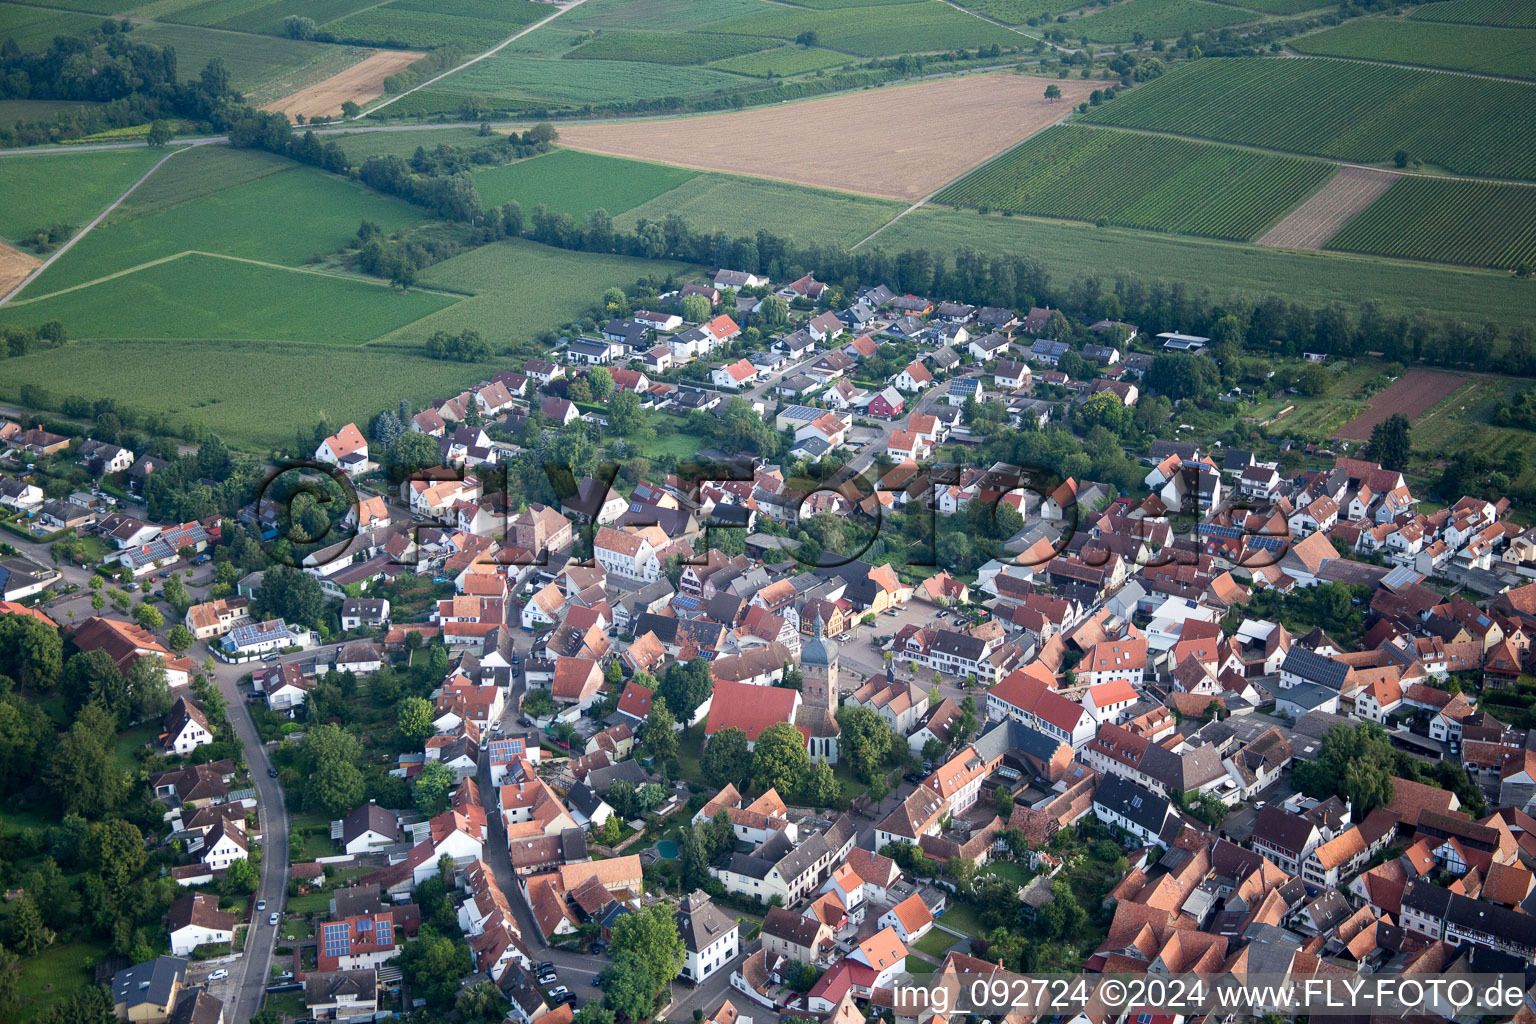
xmin=408 ymin=52 xmax=743 ymax=112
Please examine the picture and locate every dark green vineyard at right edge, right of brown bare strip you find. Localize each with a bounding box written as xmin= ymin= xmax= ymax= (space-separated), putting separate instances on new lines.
xmin=1327 ymin=177 xmax=1536 ymax=269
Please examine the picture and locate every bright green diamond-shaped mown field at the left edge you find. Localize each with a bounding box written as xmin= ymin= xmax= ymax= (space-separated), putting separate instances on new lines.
xmin=5 ymin=255 xmax=451 ymax=342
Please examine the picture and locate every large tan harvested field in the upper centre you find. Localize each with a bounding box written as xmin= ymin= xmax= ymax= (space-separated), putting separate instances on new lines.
xmin=561 ymin=72 xmax=1095 ymax=200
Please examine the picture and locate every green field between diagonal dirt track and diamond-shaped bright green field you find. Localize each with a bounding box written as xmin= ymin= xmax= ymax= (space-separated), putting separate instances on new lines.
xmin=26 ymin=154 xmax=421 ymax=294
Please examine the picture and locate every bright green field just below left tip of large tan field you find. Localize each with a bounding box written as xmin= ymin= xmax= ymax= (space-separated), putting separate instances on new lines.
xmin=475 ymin=149 xmax=697 ymax=223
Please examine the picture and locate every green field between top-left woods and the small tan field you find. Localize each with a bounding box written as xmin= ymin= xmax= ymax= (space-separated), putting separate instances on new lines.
xmin=134 ymin=25 xmax=358 ymax=100
